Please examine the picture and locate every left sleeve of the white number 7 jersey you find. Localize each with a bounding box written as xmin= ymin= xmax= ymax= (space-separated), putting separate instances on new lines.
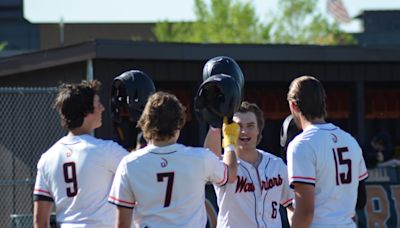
xmin=108 ymin=160 xmax=136 ymax=208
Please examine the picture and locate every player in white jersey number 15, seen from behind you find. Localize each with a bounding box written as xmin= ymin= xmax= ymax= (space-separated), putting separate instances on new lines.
xmin=287 ymin=76 xmax=368 ymax=228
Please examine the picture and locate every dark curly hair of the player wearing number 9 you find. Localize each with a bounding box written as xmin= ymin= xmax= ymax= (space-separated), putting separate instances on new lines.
xmin=53 ymin=80 xmax=101 ymax=130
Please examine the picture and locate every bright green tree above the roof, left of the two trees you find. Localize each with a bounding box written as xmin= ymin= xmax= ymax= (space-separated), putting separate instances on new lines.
xmin=154 ymin=0 xmax=263 ymax=43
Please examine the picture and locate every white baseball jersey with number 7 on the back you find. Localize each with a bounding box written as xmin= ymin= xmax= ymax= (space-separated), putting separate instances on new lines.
xmin=109 ymin=144 xmax=228 ymax=228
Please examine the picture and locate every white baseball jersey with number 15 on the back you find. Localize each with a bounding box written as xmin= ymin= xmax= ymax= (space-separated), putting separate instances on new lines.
xmin=287 ymin=123 xmax=368 ymax=226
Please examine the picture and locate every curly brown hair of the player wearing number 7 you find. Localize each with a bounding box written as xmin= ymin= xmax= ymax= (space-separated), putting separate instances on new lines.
xmin=137 ymin=92 xmax=186 ymax=141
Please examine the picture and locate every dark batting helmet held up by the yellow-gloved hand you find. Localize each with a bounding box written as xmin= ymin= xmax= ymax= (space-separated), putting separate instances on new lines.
xmin=194 ymin=74 xmax=241 ymax=128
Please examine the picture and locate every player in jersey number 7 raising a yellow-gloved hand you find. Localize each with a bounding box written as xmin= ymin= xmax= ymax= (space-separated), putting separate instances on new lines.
xmin=109 ymin=92 xmax=239 ymax=228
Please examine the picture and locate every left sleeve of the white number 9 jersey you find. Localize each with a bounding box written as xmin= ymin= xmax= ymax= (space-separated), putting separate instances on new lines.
xmin=33 ymin=156 xmax=54 ymax=201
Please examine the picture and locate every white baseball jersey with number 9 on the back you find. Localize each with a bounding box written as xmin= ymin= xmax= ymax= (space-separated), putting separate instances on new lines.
xmin=33 ymin=135 xmax=128 ymax=228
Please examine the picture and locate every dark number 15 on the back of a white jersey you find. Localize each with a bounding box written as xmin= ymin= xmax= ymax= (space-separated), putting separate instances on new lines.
xmin=332 ymin=147 xmax=351 ymax=185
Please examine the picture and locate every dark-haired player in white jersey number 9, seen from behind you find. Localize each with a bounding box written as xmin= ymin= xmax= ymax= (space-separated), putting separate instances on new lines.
xmin=33 ymin=80 xmax=128 ymax=228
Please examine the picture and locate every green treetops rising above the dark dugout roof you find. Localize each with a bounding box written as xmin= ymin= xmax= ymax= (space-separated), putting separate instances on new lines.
xmin=154 ymin=0 xmax=355 ymax=45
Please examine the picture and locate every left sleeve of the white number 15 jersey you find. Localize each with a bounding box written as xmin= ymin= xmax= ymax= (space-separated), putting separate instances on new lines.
xmin=287 ymin=141 xmax=316 ymax=188
